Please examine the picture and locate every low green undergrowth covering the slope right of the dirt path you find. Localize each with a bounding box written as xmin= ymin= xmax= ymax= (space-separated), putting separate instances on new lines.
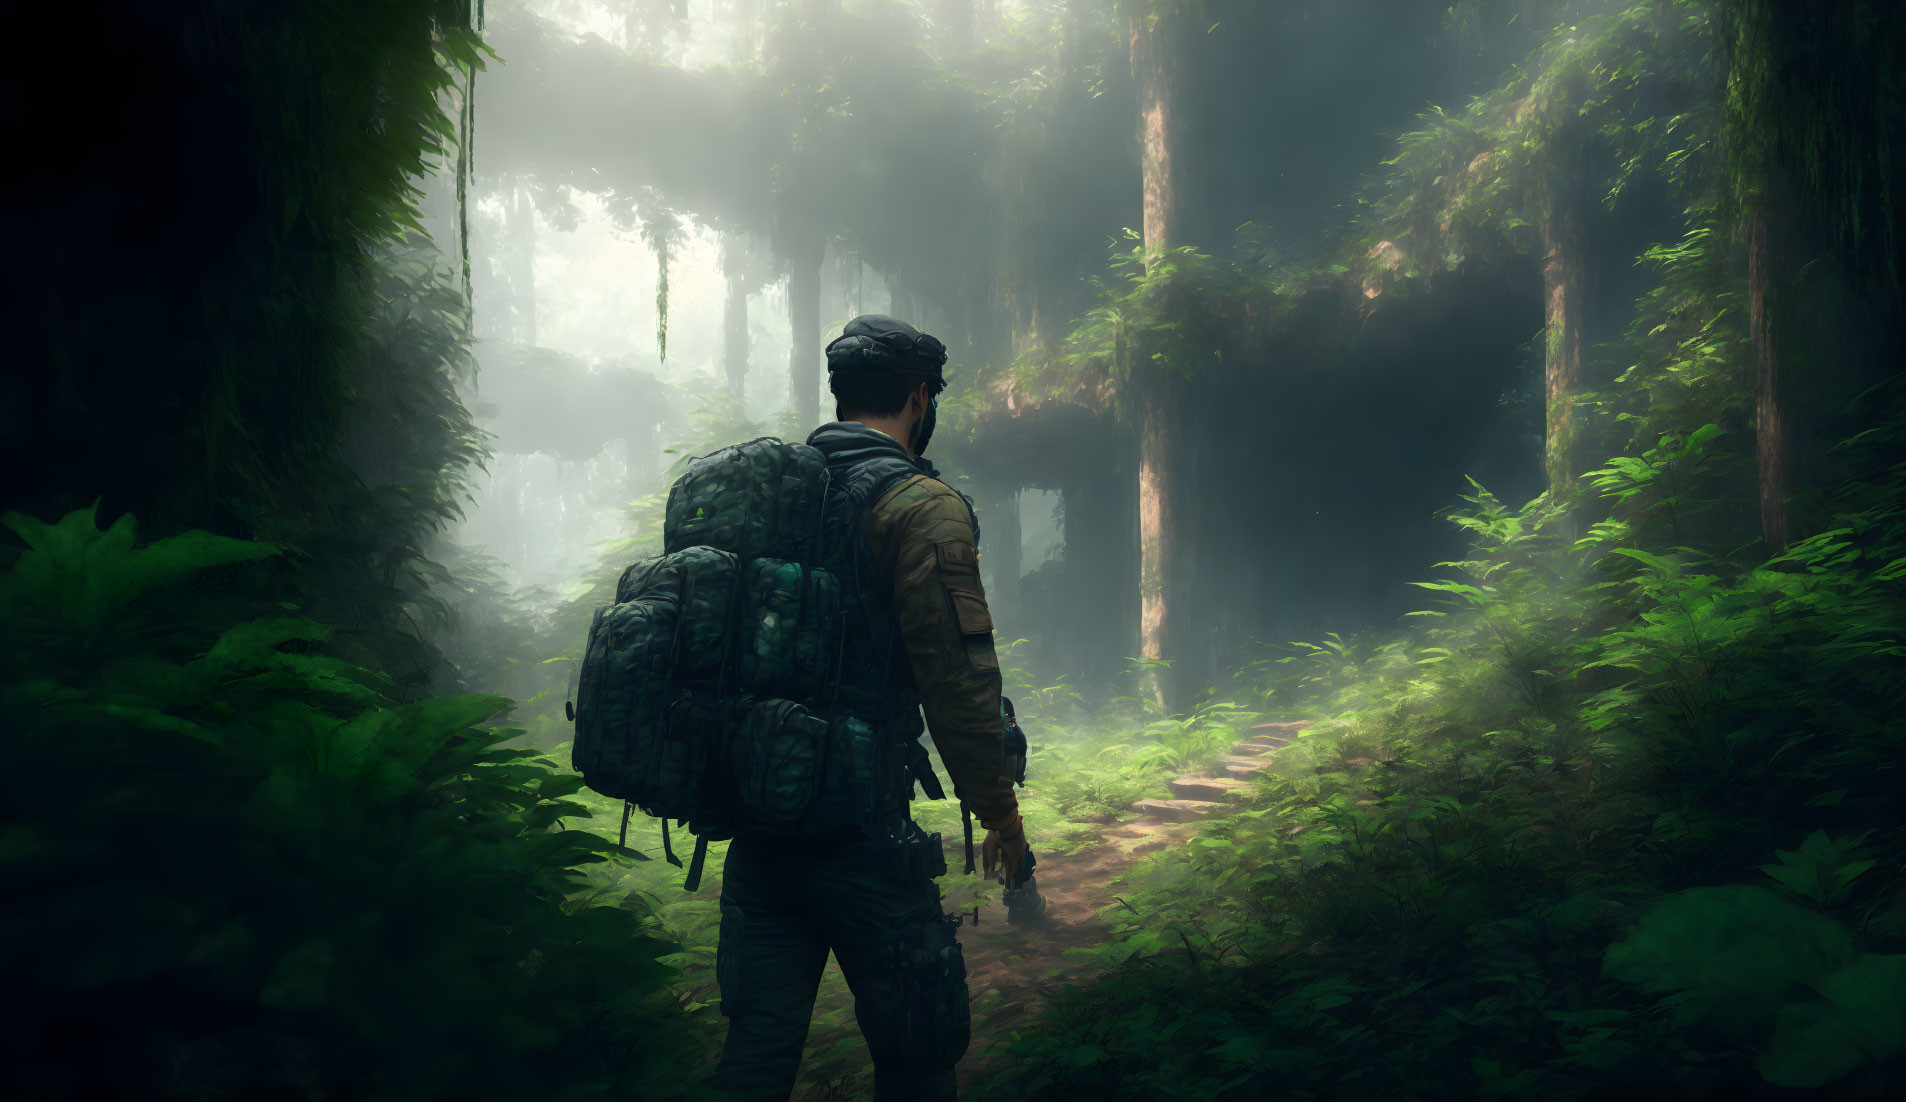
xmin=982 ymin=400 xmax=1906 ymax=1098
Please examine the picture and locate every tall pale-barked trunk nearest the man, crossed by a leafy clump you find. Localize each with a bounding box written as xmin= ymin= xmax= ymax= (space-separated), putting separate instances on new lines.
xmin=1126 ymin=15 xmax=1187 ymax=713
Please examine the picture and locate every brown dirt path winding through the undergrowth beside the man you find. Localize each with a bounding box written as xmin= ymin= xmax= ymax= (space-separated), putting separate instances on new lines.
xmin=795 ymin=723 xmax=1304 ymax=1102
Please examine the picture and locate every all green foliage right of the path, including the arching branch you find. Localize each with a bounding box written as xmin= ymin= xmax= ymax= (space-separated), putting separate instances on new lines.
xmin=960 ymin=4 xmax=1906 ymax=1098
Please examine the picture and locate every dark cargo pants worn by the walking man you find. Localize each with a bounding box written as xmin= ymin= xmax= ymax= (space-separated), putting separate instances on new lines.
xmin=713 ymin=822 xmax=968 ymax=1102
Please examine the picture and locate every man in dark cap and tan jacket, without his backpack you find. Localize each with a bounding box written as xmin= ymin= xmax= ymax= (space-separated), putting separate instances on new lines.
xmin=713 ymin=315 xmax=1025 ymax=1102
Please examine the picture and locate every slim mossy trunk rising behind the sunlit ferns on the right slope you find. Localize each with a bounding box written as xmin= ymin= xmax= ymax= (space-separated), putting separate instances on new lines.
xmin=1542 ymin=156 xmax=1588 ymax=501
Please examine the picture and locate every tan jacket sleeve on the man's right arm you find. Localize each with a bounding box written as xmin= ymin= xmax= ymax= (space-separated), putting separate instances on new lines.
xmin=881 ymin=479 xmax=1018 ymax=822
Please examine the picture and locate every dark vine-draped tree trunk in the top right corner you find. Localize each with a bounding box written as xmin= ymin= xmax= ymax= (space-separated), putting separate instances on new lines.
xmin=1717 ymin=0 xmax=1906 ymax=549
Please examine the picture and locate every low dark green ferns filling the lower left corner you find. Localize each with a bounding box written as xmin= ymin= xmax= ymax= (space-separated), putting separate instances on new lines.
xmin=0 ymin=511 xmax=709 ymax=1098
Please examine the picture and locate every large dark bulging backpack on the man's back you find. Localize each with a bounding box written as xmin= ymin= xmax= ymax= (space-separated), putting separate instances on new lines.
xmin=574 ymin=439 xmax=938 ymax=890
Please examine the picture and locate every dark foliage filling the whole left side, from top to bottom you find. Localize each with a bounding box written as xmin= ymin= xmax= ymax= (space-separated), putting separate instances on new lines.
xmin=0 ymin=0 xmax=709 ymax=1098
